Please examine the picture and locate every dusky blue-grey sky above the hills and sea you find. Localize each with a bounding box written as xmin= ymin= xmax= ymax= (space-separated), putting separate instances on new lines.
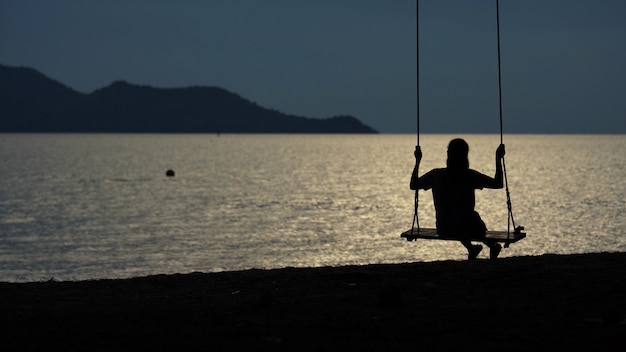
xmin=0 ymin=0 xmax=626 ymax=134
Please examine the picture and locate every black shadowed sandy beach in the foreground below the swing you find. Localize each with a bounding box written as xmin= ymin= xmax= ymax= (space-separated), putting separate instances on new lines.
xmin=0 ymin=253 xmax=626 ymax=351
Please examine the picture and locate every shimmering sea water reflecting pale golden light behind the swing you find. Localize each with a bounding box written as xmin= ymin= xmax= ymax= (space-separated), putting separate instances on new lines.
xmin=0 ymin=134 xmax=626 ymax=282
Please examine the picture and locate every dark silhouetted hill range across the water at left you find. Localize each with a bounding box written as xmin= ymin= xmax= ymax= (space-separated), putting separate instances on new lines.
xmin=0 ymin=65 xmax=377 ymax=133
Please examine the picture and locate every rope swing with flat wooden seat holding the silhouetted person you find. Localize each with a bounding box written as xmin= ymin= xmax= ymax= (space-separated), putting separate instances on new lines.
xmin=400 ymin=0 xmax=526 ymax=248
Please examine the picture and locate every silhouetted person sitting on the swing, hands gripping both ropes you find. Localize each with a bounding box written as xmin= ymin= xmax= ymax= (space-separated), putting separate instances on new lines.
xmin=410 ymin=138 xmax=505 ymax=260
